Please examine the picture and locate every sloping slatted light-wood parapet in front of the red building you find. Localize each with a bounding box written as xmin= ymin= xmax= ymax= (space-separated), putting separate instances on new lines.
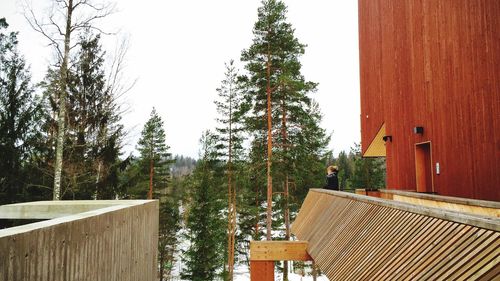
xmin=292 ymin=189 xmax=500 ymax=280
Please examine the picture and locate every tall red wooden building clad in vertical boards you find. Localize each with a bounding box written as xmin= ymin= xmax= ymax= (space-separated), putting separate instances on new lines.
xmin=359 ymin=0 xmax=500 ymax=201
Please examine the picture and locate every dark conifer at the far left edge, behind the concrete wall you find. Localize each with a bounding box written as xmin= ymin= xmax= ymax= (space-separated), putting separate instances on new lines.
xmin=0 ymin=18 xmax=42 ymax=205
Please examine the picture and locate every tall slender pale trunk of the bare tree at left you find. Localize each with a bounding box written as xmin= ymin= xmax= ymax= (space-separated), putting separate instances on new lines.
xmin=53 ymin=0 xmax=73 ymax=200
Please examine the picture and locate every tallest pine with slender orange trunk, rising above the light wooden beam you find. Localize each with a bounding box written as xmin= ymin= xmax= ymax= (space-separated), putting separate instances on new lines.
xmin=241 ymin=0 xmax=290 ymax=240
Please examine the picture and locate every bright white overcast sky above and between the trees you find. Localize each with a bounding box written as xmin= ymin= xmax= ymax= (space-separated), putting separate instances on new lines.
xmin=0 ymin=0 xmax=360 ymax=157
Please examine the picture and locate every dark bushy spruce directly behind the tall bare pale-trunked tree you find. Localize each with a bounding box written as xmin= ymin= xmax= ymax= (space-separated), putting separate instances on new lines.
xmin=42 ymin=31 xmax=123 ymax=199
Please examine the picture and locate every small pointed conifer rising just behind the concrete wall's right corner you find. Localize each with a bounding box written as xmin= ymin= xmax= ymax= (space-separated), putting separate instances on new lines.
xmin=132 ymin=107 xmax=172 ymax=199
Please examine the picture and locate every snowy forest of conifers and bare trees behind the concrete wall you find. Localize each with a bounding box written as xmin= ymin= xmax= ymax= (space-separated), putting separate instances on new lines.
xmin=0 ymin=0 xmax=385 ymax=280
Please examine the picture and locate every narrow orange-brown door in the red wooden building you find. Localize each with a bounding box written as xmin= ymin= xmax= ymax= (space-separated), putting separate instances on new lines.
xmin=415 ymin=142 xmax=434 ymax=193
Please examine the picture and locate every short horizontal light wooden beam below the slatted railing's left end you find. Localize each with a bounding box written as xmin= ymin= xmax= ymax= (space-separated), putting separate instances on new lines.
xmin=250 ymin=238 xmax=312 ymax=261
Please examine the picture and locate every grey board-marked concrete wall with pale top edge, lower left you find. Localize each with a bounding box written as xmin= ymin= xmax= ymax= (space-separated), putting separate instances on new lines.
xmin=0 ymin=200 xmax=158 ymax=281
